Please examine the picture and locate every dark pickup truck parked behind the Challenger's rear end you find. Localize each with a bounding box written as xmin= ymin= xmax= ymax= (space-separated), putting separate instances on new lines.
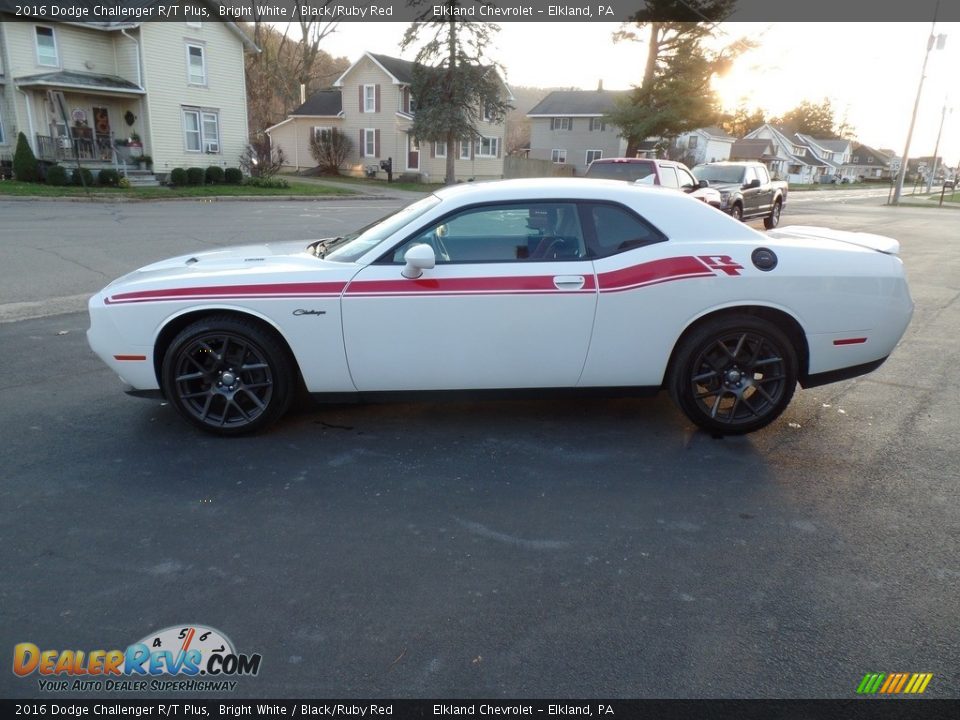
xmin=693 ymin=162 xmax=787 ymax=230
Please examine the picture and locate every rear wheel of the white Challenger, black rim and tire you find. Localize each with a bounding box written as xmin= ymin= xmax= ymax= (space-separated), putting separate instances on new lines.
xmin=668 ymin=315 xmax=798 ymax=435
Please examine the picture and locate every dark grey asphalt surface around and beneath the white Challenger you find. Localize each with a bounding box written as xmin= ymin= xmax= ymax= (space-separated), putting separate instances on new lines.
xmin=0 ymin=193 xmax=960 ymax=698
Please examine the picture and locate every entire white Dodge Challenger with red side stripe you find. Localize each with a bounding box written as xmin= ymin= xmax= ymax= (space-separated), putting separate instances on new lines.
xmin=88 ymin=178 xmax=913 ymax=434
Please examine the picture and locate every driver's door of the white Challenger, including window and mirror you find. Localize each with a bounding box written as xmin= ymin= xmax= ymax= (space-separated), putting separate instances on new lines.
xmin=342 ymin=201 xmax=597 ymax=391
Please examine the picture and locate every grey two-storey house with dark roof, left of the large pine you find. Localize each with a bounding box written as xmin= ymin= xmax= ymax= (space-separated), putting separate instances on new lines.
xmin=527 ymin=84 xmax=629 ymax=175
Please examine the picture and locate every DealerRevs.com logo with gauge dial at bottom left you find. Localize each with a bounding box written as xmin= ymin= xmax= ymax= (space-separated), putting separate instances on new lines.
xmin=13 ymin=625 xmax=262 ymax=692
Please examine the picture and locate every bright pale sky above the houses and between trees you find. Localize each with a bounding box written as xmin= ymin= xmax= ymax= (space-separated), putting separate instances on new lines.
xmin=312 ymin=22 xmax=960 ymax=166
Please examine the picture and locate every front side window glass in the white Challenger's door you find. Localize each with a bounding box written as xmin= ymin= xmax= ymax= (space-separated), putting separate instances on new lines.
xmin=381 ymin=202 xmax=587 ymax=264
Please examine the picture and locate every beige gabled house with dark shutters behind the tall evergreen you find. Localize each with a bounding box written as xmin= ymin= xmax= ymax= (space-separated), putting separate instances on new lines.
xmin=266 ymin=52 xmax=513 ymax=182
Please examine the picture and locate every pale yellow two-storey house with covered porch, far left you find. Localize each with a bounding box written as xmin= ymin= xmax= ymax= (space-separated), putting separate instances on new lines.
xmin=0 ymin=15 xmax=257 ymax=177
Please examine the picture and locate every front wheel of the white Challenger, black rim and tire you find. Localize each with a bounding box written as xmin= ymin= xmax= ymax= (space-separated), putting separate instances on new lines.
xmin=161 ymin=315 xmax=296 ymax=435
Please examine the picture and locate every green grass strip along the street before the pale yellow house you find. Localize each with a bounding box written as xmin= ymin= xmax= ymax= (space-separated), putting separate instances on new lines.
xmin=0 ymin=180 xmax=352 ymax=200
